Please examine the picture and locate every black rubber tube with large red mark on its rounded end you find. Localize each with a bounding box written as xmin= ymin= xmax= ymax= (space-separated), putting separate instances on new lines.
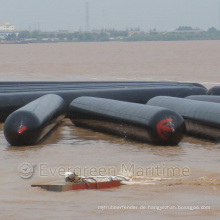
xmin=67 ymin=97 xmax=185 ymax=145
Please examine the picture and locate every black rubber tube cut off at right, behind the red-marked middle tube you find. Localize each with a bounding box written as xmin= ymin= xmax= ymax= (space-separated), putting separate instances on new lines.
xmin=147 ymin=96 xmax=220 ymax=141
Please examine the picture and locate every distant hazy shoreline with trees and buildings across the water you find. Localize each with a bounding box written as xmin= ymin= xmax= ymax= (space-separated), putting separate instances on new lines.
xmin=0 ymin=28 xmax=220 ymax=44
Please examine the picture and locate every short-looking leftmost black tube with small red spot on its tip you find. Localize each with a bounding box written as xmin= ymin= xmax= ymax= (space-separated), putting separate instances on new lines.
xmin=4 ymin=94 xmax=67 ymax=146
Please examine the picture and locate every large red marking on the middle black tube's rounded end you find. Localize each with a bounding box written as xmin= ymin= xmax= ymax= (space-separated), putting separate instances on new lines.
xmin=157 ymin=118 xmax=175 ymax=140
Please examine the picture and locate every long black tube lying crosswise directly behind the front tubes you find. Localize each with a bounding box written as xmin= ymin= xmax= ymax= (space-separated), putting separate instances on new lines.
xmin=0 ymin=86 xmax=206 ymax=122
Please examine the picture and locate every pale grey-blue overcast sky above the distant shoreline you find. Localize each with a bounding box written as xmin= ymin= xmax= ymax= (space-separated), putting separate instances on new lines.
xmin=0 ymin=0 xmax=220 ymax=31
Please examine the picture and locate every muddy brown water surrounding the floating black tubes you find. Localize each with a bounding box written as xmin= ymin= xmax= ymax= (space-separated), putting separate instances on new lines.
xmin=0 ymin=41 xmax=220 ymax=219
